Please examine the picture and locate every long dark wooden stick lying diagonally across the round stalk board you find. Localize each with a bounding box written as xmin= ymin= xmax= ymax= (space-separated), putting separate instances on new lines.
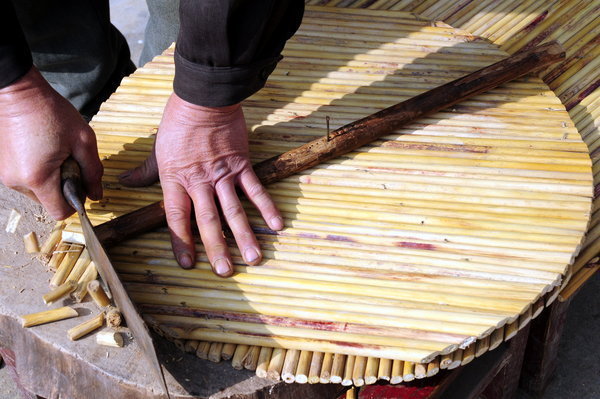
xmin=95 ymin=42 xmax=565 ymax=246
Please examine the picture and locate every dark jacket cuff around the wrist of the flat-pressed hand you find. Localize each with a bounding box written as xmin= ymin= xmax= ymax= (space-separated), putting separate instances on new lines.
xmin=173 ymin=48 xmax=283 ymax=107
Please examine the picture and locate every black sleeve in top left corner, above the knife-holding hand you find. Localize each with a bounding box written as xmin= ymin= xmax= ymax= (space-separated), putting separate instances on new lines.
xmin=0 ymin=0 xmax=32 ymax=88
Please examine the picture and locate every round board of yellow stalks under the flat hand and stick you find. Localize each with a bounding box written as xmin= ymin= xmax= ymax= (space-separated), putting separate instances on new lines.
xmin=57 ymin=7 xmax=592 ymax=385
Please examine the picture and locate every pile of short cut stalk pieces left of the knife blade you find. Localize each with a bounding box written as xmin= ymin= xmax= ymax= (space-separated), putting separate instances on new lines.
xmin=21 ymin=223 xmax=124 ymax=347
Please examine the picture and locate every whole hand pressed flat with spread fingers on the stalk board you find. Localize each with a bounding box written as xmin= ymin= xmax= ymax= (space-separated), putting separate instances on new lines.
xmin=121 ymin=94 xmax=283 ymax=277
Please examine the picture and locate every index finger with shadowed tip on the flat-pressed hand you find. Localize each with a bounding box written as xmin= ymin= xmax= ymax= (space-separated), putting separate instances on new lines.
xmin=163 ymin=181 xmax=196 ymax=269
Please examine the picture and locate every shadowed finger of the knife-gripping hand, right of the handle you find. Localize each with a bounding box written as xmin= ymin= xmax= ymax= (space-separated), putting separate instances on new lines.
xmin=72 ymin=126 xmax=104 ymax=200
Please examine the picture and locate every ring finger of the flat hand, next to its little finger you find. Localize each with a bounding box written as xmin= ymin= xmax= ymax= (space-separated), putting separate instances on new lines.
xmin=216 ymin=181 xmax=262 ymax=265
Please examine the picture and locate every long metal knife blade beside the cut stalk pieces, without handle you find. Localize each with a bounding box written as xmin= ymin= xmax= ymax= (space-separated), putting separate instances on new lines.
xmin=77 ymin=210 xmax=170 ymax=398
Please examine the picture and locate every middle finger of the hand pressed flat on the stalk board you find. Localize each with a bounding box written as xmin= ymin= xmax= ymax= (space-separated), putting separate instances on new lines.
xmin=189 ymin=185 xmax=233 ymax=277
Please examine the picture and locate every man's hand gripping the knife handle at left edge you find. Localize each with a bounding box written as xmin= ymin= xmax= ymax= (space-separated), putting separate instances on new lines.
xmin=0 ymin=68 xmax=103 ymax=220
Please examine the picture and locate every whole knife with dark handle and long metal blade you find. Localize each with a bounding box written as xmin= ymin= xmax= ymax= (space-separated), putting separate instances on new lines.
xmin=61 ymin=157 xmax=171 ymax=398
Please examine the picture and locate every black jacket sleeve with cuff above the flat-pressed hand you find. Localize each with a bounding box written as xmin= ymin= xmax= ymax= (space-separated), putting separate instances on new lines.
xmin=173 ymin=0 xmax=304 ymax=107
